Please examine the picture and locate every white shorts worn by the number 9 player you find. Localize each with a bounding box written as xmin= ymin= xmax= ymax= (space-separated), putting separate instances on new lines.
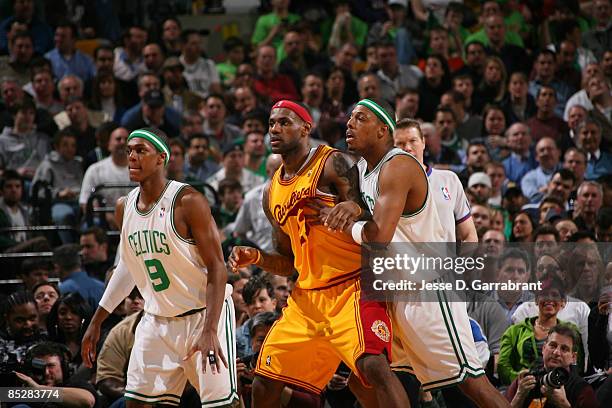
xmin=125 ymin=286 xmax=238 ymax=407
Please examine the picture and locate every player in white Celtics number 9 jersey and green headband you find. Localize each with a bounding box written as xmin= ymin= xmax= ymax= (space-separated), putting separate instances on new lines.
xmin=81 ymin=128 xmax=238 ymax=408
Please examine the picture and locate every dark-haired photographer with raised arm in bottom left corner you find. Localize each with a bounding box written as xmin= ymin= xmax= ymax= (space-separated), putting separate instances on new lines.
xmin=15 ymin=341 xmax=96 ymax=408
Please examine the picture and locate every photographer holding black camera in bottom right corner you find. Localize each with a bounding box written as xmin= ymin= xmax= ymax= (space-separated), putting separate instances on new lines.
xmin=506 ymin=324 xmax=600 ymax=408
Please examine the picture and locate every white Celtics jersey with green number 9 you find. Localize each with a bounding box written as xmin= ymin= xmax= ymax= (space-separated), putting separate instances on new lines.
xmin=120 ymin=181 xmax=206 ymax=317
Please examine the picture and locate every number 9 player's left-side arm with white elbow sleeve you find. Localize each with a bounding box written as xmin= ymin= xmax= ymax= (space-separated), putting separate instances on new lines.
xmin=81 ymin=197 xmax=134 ymax=368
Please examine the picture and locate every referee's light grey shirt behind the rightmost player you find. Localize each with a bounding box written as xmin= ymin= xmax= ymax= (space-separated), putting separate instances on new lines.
xmin=427 ymin=167 xmax=471 ymax=242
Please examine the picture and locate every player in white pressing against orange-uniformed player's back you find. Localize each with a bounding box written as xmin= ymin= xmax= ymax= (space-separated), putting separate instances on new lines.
xmin=322 ymin=99 xmax=509 ymax=408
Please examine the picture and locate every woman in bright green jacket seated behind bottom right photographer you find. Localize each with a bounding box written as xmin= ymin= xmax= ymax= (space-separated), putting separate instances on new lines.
xmin=497 ymin=275 xmax=584 ymax=385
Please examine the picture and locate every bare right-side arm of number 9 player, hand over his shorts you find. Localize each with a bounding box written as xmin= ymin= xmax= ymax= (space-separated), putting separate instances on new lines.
xmin=178 ymin=188 xmax=233 ymax=373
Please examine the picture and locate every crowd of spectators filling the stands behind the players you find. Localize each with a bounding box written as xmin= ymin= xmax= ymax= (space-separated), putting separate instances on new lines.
xmin=0 ymin=0 xmax=612 ymax=407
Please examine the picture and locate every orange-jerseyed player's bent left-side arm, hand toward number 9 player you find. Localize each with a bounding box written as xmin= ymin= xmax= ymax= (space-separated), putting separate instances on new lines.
xmin=228 ymin=183 xmax=295 ymax=276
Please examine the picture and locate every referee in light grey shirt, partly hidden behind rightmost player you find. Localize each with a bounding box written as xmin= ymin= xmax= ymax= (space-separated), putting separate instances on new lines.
xmin=393 ymin=119 xmax=478 ymax=243
